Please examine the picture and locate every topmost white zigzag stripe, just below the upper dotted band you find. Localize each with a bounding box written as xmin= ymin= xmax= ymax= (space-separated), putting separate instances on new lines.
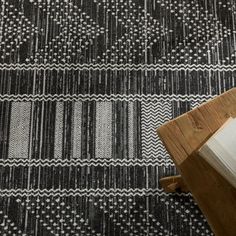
xmin=0 ymin=63 xmax=236 ymax=71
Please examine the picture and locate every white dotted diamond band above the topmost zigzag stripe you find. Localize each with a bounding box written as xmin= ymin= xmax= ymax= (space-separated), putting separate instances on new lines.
xmin=0 ymin=0 xmax=236 ymax=65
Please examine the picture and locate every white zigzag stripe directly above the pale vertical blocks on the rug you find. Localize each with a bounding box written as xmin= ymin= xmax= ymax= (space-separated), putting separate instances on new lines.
xmin=0 ymin=94 xmax=216 ymax=102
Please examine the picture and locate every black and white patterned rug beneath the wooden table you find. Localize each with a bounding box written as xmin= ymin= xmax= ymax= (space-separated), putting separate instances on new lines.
xmin=0 ymin=0 xmax=236 ymax=236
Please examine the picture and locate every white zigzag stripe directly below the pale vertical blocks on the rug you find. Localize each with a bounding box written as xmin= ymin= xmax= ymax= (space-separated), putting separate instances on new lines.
xmin=0 ymin=158 xmax=173 ymax=167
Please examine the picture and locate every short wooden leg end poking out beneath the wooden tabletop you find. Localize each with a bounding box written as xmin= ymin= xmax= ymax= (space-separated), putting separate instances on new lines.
xmin=160 ymin=175 xmax=189 ymax=193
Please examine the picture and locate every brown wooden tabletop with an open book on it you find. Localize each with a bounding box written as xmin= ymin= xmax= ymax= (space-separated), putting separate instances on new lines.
xmin=157 ymin=88 xmax=236 ymax=236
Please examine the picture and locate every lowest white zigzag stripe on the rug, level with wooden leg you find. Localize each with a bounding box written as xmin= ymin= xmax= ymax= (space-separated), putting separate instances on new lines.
xmin=1 ymin=188 xmax=191 ymax=197
